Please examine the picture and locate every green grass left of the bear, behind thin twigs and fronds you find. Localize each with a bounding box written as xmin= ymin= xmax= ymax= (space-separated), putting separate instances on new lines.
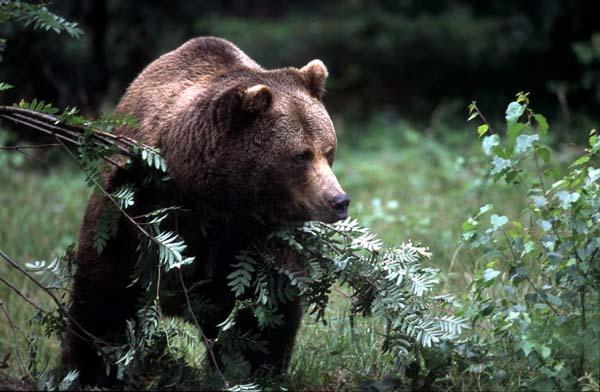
xmin=0 ymin=151 xmax=89 ymax=376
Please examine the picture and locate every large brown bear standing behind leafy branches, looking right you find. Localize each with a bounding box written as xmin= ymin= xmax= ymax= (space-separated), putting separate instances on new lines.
xmin=61 ymin=37 xmax=349 ymax=385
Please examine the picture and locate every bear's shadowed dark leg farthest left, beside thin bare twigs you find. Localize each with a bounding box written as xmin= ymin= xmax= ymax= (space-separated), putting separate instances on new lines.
xmin=61 ymin=197 xmax=139 ymax=386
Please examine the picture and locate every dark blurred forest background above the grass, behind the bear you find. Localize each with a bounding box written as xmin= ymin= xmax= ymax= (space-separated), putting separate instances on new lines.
xmin=0 ymin=0 xmax=600 ymax=133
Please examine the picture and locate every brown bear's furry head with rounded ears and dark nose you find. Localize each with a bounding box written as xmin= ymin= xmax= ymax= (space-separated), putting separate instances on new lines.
xmin=164 ymin=60 xmax=350 ymax=223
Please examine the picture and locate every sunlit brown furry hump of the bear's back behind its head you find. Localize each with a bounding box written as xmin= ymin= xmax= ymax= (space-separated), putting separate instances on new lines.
xmin=115 ymin=37 xmax=262 ymax=147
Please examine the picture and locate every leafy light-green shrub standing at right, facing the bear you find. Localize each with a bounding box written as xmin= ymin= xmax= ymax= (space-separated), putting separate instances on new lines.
xmin=442 ymin=93 xmax=600 ymax=390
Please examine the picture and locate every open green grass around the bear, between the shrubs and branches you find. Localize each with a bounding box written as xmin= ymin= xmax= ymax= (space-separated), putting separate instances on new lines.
xmin=0 ymin=109 xmax=593 ymax=390
